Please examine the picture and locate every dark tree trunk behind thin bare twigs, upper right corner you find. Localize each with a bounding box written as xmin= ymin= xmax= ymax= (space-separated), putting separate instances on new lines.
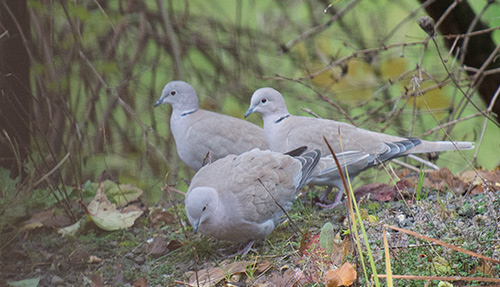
xmin=420 ymin=0 xmax=500 ymax=122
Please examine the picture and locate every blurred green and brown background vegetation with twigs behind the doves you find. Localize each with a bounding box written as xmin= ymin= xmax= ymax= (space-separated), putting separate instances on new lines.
xmin=0 ymin=0 xmax=500 ymax=216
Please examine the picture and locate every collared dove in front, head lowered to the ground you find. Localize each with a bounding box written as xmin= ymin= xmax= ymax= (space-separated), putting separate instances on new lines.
xmin=185 ymin=149 xmax=321 ymax=253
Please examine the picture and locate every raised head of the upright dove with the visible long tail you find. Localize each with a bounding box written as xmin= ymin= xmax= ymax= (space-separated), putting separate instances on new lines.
xmin=245 ymin=88 xmax=288 ymax=119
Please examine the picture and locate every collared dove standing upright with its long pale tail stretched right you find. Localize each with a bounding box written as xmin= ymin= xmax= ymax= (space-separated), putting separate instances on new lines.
xmin=245 ymin=88 xmax=474 ymax=208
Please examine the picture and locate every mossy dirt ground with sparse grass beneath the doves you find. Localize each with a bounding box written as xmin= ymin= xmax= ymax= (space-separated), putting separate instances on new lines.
xmin=0 ymin=180 xmax=500 ymax=286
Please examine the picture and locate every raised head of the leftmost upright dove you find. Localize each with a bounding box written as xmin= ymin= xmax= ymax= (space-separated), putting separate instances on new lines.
xmin=155 ymin=81 xmax=198 ymax=112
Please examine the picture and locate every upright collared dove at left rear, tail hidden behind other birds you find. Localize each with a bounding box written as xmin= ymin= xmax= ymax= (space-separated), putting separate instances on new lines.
xmin=155 ymin=81 xmax=267 ymax=171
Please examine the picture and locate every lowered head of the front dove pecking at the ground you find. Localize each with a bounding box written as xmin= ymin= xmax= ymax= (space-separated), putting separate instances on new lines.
xmin=185 ymin=186 xmax=219 ymax=233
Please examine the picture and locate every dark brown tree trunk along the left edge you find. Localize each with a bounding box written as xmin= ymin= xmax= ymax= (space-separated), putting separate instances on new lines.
xmin=0 ymin=0 xmax=31 ymax=178
